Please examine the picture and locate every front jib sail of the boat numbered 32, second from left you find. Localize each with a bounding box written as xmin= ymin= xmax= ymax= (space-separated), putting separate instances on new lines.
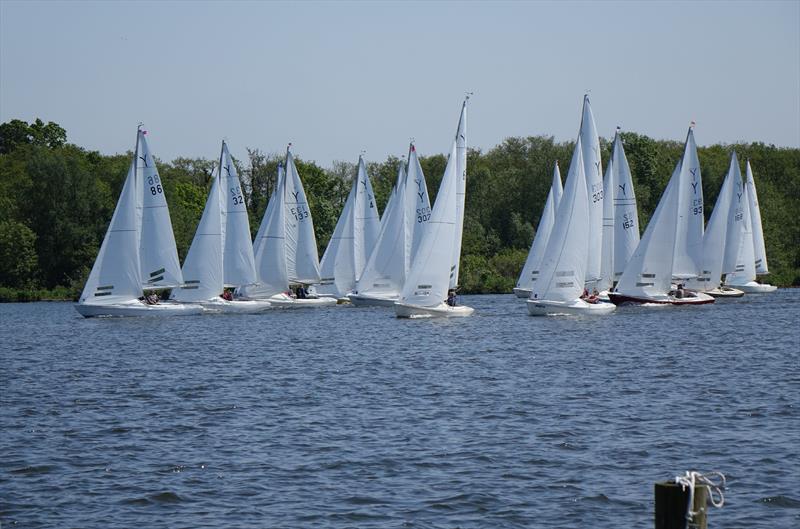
xmin=171 ymin=161 xmax=224 ymax=302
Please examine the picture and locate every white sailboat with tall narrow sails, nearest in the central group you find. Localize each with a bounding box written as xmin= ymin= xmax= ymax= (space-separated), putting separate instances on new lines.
xmin=394 ymin=98 xmax=475 ymax=318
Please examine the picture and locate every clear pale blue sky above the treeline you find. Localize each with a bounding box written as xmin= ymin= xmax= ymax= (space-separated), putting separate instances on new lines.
xmin=0 ymin=0 xmax=800 ymax=166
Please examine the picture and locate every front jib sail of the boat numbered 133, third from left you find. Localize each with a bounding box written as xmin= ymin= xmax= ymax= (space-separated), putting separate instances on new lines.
xmin=247 ymin=164 xmax=289 ymax=298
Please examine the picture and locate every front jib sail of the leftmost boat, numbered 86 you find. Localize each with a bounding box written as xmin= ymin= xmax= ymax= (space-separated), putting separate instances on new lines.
xmin=79 ymin=159 xmax=142 ymax=305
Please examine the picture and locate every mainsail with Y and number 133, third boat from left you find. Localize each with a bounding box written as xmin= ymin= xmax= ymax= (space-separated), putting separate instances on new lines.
xmin=284 ymin=149 xmax=320 ymax=284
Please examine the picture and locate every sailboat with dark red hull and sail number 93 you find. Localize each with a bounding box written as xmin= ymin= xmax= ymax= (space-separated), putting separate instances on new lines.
xmin=608 ymin=125 xmax=714 ymax=305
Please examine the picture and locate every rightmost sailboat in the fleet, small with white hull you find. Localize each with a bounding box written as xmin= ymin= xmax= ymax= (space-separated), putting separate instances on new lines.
xmin=725 ymin=160 xmax=778 ymax=294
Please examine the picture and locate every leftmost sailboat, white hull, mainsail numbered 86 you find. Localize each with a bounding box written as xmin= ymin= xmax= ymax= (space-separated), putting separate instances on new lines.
xmin=75 ymin=126 xmax=203 ymax=318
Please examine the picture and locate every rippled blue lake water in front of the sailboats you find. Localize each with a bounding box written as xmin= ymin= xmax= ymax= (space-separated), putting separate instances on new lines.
xmin=0 ymin=290 xmax=800 ymax=529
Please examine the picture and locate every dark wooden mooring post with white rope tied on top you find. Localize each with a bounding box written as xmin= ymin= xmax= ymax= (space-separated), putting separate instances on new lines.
xmin=655 ymin=481 xmax=708 ymax=529
